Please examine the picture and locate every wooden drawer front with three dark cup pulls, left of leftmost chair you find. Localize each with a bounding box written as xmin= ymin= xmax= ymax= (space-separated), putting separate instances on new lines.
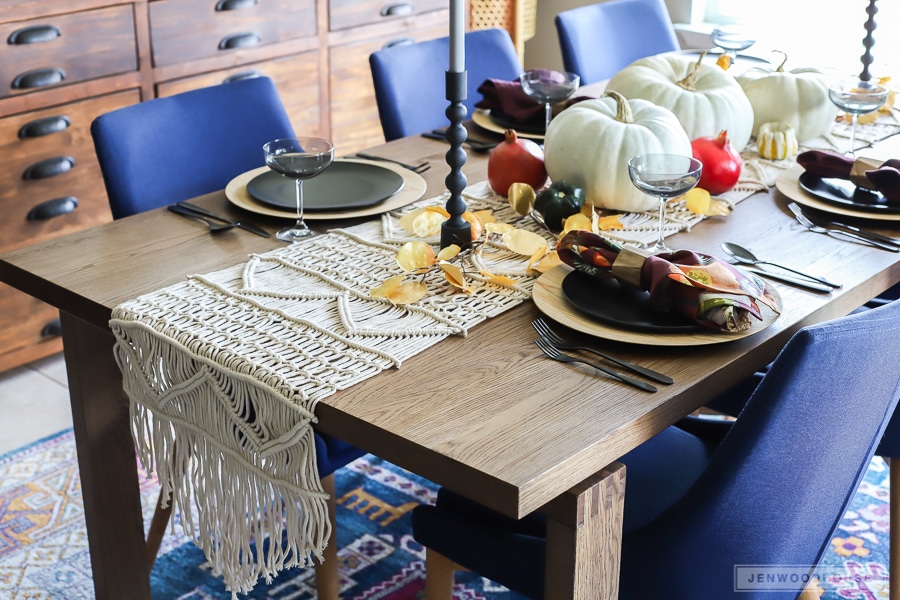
xmin=0 ymin=90 xmax=140 ymax=251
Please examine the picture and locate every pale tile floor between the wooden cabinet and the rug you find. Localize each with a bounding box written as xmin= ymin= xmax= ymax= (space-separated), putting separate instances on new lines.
xmin=0 ymin=353 xmax=72 ymax=455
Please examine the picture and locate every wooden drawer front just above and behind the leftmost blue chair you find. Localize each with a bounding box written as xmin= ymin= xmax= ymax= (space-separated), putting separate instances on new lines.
xmin=156 ymin=52 xmax=322 ymax=137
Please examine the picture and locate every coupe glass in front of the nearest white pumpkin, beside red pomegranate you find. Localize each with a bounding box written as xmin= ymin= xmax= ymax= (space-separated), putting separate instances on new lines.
xmin=628 ymin=154 xmax=703 ymax=254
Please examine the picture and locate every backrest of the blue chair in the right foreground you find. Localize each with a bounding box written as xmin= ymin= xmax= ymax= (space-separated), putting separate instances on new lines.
xmin=623 ymin=301 xmax=900 ymax=600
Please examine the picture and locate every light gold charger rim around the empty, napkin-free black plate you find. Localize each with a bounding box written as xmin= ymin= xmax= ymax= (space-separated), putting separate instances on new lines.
xmin=225 ymin=158 xmax=428 ymax=221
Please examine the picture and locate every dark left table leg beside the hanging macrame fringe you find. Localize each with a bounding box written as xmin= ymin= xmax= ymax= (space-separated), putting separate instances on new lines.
xmin=60 ymin=313 xmax=150 ymax=600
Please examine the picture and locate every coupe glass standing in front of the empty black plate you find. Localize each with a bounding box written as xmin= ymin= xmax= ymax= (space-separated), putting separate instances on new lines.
xmin=263 ymin=137 xmax=334 ymax=242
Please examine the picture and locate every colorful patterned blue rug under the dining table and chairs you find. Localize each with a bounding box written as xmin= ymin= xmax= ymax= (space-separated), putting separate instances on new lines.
xmin=0 ymin=430 xmax=889 ymax=600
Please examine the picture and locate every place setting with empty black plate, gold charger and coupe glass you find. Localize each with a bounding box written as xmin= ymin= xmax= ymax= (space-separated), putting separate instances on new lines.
xmin=225 ymin=138 xmax=427 ymax=223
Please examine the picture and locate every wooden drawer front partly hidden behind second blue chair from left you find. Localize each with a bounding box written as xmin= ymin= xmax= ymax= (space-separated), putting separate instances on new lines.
xmin=330 ymin=27 xmax=447 ymax=154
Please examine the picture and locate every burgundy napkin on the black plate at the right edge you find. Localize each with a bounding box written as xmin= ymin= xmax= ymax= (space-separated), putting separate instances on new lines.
xmin=797 ymin=150 xmax=900 ymax=206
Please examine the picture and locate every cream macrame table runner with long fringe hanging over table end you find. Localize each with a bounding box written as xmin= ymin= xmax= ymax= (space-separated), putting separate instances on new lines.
xmin=110 ymin=112 xmax=892 ymax=593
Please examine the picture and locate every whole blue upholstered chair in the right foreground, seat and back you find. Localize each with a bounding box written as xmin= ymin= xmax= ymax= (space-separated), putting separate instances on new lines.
xmin=413 ymin=302 xmax=900 ymax=600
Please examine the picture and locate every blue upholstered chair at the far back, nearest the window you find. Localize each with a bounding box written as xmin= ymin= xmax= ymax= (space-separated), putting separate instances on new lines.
xmin=556 ymin=0 xmax=680 ymax=85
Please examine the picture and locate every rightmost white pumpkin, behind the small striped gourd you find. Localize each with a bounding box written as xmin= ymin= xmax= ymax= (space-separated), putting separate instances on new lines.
xmin=737 ymin=50 xmax=837 ymax=144
